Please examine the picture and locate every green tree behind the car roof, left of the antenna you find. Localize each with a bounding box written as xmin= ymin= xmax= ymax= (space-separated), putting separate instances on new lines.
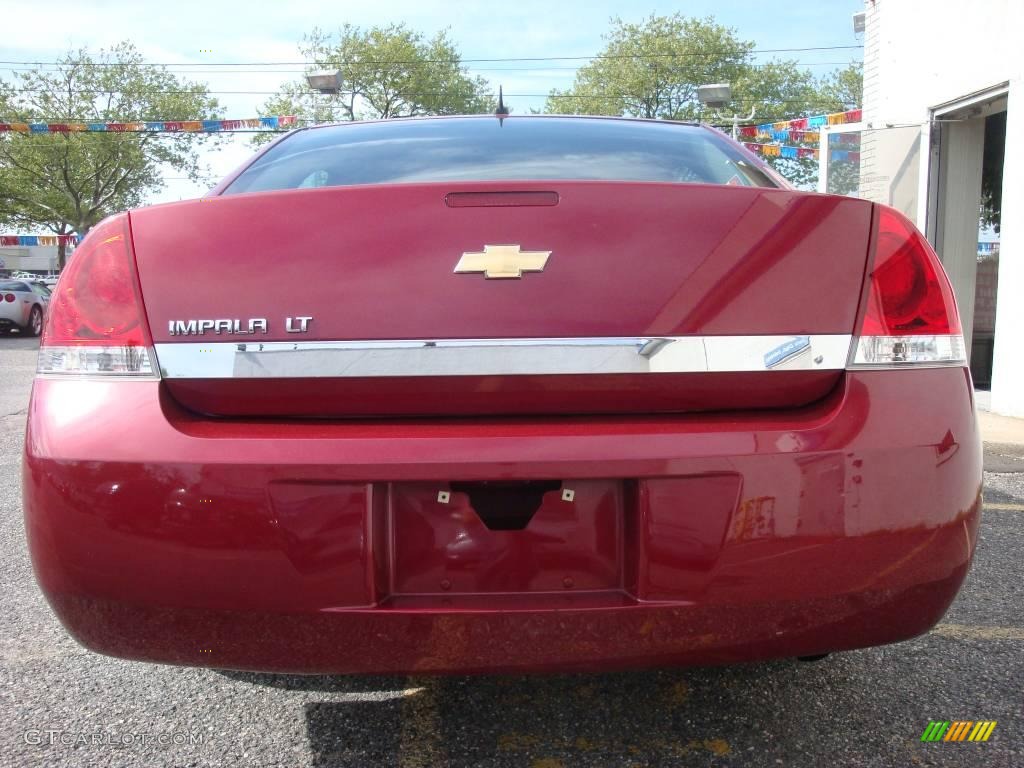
xmin=254 ymin=24 xmax=494 ymax=143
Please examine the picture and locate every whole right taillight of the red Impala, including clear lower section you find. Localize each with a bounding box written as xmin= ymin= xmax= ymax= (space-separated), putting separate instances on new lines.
xmin=851 ymin=206 xmax=966 ymax=367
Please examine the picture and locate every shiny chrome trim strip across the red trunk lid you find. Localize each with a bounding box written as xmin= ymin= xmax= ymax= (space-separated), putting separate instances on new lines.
xmin=156 ymin=334 xmax=852 ymax=379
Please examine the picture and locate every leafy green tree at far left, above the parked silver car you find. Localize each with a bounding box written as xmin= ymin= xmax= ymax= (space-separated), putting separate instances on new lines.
xmin=0 ymin=42 xmax=219 ymax=267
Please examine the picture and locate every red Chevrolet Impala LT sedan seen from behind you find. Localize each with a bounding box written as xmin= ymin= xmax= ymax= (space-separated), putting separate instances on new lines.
xmin=24 ymin=116 xmax=981 ymax=673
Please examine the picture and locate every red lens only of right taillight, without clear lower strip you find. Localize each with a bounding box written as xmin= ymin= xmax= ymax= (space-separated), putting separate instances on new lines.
xmin=860 ymin=206 xmax=961 ymax=336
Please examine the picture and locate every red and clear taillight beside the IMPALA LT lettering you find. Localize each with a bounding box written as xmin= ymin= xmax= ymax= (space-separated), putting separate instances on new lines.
xmin=38 ymin=214 xmax=157 ymax=378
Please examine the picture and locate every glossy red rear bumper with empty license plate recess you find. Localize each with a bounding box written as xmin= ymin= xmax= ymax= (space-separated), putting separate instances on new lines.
xmin=24 ymin=369 xmax=981 ymax=673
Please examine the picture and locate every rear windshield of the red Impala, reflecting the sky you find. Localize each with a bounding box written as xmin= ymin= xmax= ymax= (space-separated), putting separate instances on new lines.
xmin=223 ymin=117 xmax=776 ymax=195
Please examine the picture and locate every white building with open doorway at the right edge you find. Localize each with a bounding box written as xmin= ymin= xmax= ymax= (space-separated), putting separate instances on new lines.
xmin=860 ymin=0 xmax=1024 ymax=417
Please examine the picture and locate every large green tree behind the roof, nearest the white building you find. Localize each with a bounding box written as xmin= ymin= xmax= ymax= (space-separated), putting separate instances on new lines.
xmin=545 ymin=13 xmax=861 ymax=191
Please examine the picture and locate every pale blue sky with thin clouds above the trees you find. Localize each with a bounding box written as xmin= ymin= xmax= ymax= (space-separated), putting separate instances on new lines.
xmin=0 ymin=0 xmax=863 ymax=203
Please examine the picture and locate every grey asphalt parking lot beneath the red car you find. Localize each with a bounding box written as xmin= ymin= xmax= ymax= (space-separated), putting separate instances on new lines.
xmin=0 ymin=337 xmax=1024 ymax=768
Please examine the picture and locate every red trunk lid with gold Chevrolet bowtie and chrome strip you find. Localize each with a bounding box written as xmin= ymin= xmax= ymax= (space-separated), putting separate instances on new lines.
xmin=131 ymin=181 xmax=870 ymax=418
